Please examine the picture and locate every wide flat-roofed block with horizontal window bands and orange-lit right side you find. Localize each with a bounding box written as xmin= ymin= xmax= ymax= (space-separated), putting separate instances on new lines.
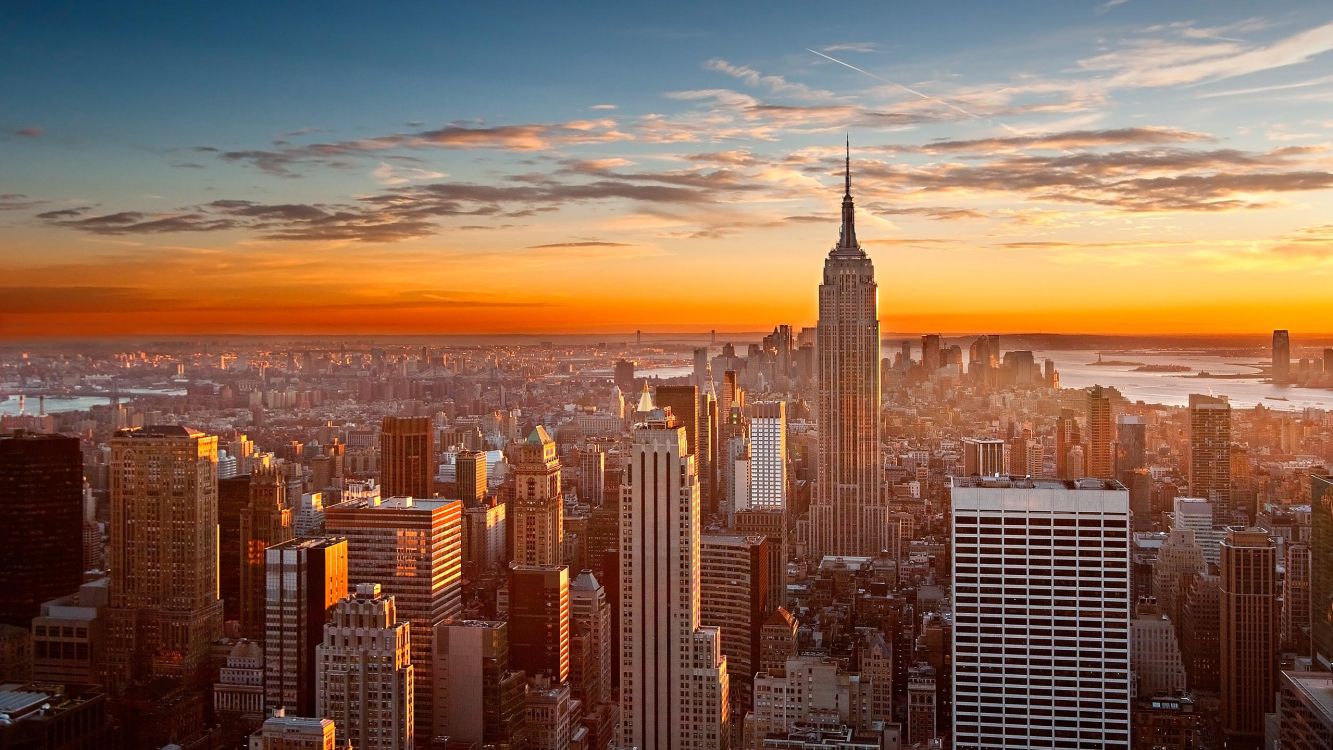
xmin=324 ymin=497 xmax=463 ymax=737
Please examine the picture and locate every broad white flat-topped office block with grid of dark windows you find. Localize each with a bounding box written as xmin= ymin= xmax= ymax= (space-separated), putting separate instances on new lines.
xmin=952 ymin=477 xmax=1130 ymax=750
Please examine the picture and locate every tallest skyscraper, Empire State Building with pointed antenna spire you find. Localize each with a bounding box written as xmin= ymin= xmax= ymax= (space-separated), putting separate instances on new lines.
xmin=810 ymin=143 xmax=881 ymax=557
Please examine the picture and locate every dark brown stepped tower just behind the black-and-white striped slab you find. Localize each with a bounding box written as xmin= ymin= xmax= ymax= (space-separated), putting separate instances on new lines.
xmin=237 ymin=468 xmax=293 ymax=639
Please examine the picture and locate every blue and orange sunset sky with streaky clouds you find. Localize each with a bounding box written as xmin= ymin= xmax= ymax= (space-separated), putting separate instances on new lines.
xmin=0 ymin=0 xmax=1333 ymax=338
